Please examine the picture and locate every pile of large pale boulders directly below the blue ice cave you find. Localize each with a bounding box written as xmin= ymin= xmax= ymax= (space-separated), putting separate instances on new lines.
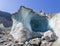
xmin=27 ymin=30 xmax=56 ymax=46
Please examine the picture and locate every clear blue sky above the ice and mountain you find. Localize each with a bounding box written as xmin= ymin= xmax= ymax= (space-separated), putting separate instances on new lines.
xmin=0 ymin=0 xmax=60 ymax=13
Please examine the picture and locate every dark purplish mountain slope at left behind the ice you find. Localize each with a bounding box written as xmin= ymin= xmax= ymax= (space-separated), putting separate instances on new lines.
xmin=0 ymin=11 xmax=12 ymax=27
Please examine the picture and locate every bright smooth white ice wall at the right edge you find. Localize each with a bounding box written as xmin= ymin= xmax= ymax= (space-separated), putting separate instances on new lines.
xmin=49 ymin=13 xmax=60 ymax=46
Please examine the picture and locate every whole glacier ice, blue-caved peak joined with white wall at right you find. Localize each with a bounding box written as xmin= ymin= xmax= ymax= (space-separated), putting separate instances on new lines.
xmin=10 ymin=6 xmax=60 ymax=46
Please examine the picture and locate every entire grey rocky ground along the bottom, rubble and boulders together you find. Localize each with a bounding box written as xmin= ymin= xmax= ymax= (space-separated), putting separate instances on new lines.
xmin=0 ymin=30 xmax=56 ymax=46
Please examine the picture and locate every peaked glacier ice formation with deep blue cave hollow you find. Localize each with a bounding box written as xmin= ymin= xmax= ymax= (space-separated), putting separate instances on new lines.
xmin=10 ymin=6 xmax=50 ymax=43
